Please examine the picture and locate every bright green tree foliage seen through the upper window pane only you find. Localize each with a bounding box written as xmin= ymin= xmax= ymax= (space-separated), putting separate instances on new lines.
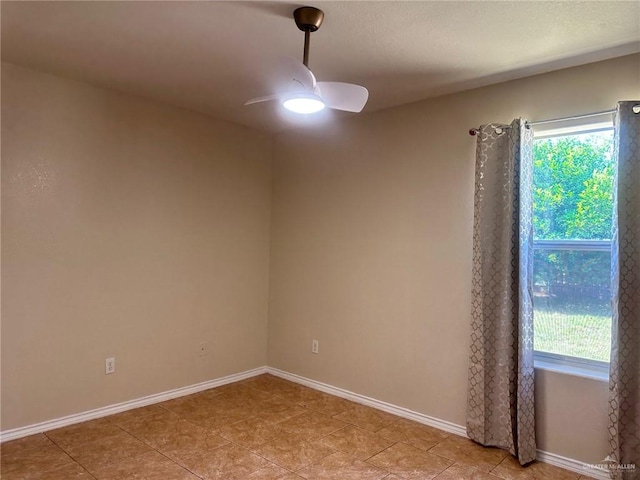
xmin=533 ymin=132 xmax=613 ymax=240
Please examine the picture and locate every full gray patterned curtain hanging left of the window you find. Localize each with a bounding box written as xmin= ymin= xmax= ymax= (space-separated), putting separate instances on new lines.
xmin=467 ymin=119 xmax=536 ymax=465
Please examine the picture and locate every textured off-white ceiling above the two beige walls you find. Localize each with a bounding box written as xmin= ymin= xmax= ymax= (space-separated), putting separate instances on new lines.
xmin=1 ymin=0 xmax=640 ymax=131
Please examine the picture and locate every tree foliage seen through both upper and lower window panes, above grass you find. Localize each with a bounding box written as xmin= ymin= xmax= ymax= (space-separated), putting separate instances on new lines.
xmin=533 ymin=132 xmax=614 ymax=296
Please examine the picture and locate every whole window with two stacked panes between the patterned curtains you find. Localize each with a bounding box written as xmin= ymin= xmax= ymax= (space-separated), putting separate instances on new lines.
xmin=533 ymin=125 xmax=614 ymax=378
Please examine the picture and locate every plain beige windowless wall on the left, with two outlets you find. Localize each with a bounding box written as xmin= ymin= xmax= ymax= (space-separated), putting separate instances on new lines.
xmin=1 ymin=64 xmax=271 ymax=430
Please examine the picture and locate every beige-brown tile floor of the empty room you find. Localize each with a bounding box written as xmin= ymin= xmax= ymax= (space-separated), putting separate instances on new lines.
xmin=0 ymin=375 xmax=600 ymax=480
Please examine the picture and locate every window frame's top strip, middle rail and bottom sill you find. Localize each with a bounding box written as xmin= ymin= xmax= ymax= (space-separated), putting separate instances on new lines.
xmin=533 ymin=121 xmax=613 ymax=381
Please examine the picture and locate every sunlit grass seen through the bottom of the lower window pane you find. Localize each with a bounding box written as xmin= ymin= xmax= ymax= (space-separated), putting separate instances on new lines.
xmin=533 ymin=308 xmax=611 ymax=362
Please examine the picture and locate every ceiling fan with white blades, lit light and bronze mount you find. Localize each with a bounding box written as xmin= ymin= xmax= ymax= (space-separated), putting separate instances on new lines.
xmin=245 ymin=7 xmax=369 ymax=114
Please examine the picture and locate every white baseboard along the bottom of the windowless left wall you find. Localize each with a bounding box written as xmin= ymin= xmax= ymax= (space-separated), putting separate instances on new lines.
xmin=0 ymin=367 xmax=267 ymax=443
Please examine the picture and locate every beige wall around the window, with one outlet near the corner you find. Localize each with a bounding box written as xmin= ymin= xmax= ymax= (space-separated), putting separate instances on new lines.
xmin=268 ymin=55 xmax=640 ymax=462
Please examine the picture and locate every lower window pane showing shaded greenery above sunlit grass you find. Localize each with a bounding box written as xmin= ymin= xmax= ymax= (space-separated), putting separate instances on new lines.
xmin=533 ymin=249 xmax=611 ymax=362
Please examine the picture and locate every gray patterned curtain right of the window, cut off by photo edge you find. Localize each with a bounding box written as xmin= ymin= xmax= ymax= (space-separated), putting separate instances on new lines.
xmin=609 ymin=102 xmax=640 ymax=480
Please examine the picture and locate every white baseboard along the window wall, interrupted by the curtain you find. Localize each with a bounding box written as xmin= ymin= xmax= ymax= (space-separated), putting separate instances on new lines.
xmin=266 ymin=367 xmax=610 ymax=480
